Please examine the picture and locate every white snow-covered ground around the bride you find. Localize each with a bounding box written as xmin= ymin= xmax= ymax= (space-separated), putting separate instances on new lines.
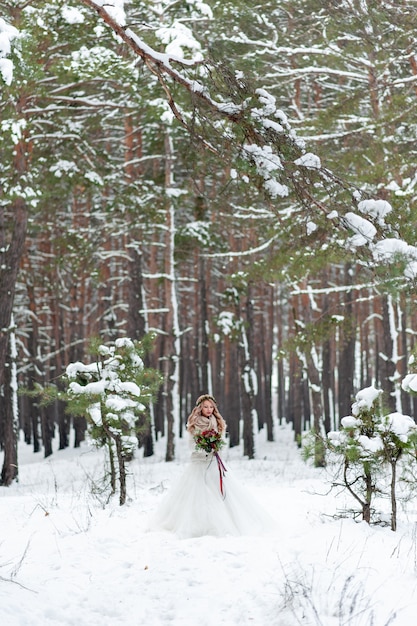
xmin=0 ymin=426 xmax=417 ymax=626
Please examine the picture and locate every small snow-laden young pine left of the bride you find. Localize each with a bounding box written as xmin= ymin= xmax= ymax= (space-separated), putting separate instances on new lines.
xmin=66 ymin=338 xmax=160 ymax=505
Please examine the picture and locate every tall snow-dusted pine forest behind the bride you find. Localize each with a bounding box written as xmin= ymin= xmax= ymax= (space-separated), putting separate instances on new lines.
xmin=0 ymin=0 xmax=417 ymax=484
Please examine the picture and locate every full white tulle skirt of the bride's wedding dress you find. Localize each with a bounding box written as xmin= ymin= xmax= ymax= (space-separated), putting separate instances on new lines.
xmin=149 ymin=438 xmax=274 ymax=538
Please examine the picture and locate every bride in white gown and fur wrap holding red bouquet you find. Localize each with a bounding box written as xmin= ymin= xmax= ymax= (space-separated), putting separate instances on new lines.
xmin=150 ymin=394 xmax=274 ymax=538
